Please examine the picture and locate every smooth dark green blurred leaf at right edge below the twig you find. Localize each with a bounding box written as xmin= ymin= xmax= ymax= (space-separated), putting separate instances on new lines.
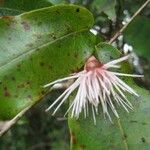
xmin=124 ymin=16 xmax=150 ymax=59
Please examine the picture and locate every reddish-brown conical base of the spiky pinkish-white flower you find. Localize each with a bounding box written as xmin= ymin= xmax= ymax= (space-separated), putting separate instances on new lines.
xmin=84 ymin=56 xmax=103 ymax=71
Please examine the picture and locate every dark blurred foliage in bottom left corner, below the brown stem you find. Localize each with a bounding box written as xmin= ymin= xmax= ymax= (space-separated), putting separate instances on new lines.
xmin=0 ymin=91 xmax=69 ymax=150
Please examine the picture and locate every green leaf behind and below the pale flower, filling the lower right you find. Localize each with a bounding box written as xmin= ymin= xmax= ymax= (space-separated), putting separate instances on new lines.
xmin=68 ymin=43 xmax=150 ymax=150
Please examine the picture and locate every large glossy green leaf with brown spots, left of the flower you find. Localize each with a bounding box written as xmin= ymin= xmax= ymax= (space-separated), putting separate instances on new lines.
xmin=0 ymin=5 xmax=96 ymax=119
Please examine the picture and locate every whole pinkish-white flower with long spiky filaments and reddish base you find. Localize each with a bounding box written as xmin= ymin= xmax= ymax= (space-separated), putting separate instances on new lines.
xmin=44 ymin=55 xmax=143 ymax=124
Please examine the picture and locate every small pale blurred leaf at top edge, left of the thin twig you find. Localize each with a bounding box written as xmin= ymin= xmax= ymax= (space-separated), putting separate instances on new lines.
xmin=92 ymin=0 xmax=116 ymax=20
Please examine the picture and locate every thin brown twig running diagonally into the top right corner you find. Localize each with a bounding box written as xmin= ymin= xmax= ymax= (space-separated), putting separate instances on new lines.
xmin=108 ymin=0 xmax=150 ymax=44
